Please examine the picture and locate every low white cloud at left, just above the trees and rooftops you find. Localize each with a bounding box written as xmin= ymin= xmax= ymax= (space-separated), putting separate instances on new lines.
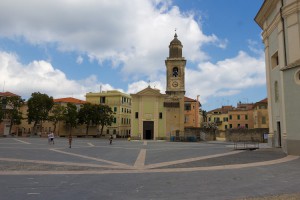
xmin=0 ymin=52 xmax=114 ymax=99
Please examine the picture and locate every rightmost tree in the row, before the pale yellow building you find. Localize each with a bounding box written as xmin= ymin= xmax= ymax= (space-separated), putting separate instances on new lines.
xmin=95 ymin=104 xmax=114 ymax=136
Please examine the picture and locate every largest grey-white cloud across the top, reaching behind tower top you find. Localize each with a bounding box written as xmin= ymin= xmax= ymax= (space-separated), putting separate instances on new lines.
xmin=0 ymin=0 xmax=220 ymax=80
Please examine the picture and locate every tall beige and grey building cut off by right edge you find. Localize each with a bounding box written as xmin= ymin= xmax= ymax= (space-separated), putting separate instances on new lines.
xmin=255 ymin=0 xmax=300 ymax=155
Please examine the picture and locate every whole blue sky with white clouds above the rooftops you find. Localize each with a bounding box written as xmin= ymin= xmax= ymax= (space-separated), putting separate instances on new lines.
xmin=0 ymin=0 xmax=267 ymax=111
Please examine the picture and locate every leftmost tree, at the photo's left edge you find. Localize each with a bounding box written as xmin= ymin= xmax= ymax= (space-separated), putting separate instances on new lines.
xmin=4 ymin=96 xmax=24 ymax=134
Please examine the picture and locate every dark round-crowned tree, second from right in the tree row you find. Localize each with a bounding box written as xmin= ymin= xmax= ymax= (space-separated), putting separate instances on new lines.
xmin=78 ymin=103 xmax=97 ymax=135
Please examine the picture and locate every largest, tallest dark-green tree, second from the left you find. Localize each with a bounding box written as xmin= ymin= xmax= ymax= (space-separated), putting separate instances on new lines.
xmin=27 ymin=92 xmax=54 ymax=132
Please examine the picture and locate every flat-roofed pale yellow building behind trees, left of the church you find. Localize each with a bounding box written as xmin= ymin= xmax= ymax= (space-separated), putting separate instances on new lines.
xmin=85 ymin=90 xmax=131 ymax=137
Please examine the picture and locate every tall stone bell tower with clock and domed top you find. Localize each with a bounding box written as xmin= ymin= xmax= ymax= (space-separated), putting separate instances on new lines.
xmin=164 ymin=33 xmax=186 ymax=136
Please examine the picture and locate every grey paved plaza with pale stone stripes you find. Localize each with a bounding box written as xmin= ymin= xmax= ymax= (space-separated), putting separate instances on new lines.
xmin=0 ymin=138 xmax=300 ymax=200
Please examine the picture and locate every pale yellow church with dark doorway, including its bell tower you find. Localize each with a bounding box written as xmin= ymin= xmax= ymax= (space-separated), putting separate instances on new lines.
xmin=131 ymin=33 xmax=188 ymax=139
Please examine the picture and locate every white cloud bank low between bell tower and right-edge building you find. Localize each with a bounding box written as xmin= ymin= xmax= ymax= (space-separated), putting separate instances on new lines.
xmin=186 ymin=51 xmax=266 ymax=103
